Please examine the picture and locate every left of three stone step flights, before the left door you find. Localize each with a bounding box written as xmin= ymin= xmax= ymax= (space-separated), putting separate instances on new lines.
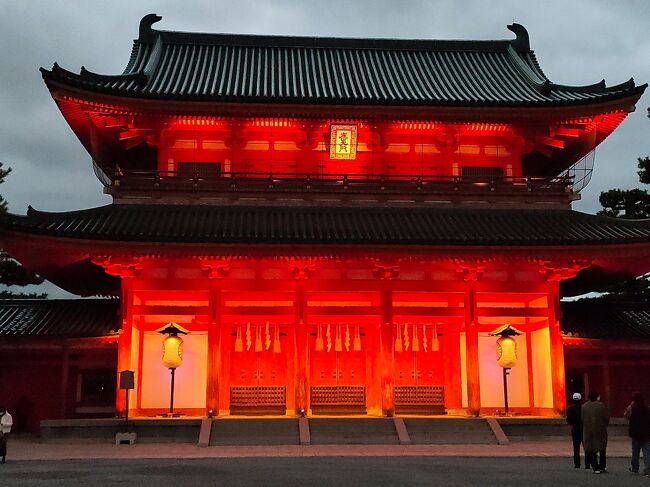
xmin=209 ymin=418 xmax=300 ymax=446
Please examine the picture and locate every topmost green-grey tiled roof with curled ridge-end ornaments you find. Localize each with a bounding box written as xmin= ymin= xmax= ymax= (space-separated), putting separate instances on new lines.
xmin=42 ymin=14 xmax=647 ymax=106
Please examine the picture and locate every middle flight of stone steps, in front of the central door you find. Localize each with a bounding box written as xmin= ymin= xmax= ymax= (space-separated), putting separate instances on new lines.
xmin=309 ymin=418 xmax=399 ymax=445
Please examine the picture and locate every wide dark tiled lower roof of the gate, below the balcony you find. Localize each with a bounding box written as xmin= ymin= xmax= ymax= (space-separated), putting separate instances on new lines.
xmin=3 ymin=204 xmax=650 ymax=246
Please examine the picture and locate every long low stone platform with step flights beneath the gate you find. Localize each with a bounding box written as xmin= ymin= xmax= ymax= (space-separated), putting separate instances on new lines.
xmin=38 ymin=416 xmax=627 ymax=447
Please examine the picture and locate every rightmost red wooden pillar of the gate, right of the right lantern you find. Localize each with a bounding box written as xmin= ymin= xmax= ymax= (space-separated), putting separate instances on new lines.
xmin=548 ymin=275 xmax=566 ymax=415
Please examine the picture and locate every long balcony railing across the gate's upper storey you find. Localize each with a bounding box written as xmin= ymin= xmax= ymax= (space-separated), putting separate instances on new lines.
xmin=111 ymin=171 xmax=572 ymax=194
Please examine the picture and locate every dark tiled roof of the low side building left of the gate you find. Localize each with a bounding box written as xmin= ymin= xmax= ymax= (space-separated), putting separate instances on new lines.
xmin=0 ymin=299 xmax=120 ymax=338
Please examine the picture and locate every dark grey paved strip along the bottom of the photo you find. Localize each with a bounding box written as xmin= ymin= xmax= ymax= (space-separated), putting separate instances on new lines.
xmin=0 ymin=456 xmax=650 ymax=487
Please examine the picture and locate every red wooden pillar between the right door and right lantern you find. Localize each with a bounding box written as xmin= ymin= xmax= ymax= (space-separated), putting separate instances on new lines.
xmin=463 ymin=269 xmax=481 ymax=416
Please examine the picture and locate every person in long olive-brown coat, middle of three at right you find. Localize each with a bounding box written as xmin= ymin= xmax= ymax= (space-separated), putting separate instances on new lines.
xmin=582 ymin=391 xmax=609 ymax=473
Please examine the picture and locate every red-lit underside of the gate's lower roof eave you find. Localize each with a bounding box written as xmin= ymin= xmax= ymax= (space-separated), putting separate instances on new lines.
xmin=5 ymin=225 xmax=650 ymax=296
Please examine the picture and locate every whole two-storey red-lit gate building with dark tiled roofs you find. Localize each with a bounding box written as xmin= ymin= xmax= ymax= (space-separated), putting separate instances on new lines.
xmin=3 ymin=15 xmax=650 ymax=416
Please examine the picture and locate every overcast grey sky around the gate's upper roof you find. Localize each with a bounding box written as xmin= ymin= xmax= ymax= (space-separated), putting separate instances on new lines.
xmin=0 ymin=0 xmax=650 ymax=298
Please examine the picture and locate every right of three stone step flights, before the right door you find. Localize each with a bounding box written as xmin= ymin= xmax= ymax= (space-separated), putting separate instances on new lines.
xmin=403 ymin=418 xmax=497 ymax=445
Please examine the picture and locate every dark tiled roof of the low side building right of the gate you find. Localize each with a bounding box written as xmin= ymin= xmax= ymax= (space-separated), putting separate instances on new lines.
xmin=562 ymin=299 xmax=650 ymax=339
